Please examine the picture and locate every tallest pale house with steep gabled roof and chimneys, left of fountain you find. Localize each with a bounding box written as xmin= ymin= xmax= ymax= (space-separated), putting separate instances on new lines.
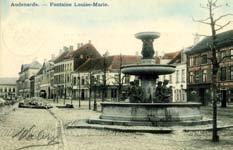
xmin=54 ymin=42 xmax=101 ymax=98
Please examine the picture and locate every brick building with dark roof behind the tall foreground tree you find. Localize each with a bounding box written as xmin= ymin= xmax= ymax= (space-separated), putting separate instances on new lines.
xmin=187 ymin=30 xmax=233 ymax=105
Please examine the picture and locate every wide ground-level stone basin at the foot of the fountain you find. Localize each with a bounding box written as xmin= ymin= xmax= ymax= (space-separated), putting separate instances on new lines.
xmin=88 ymin=102 xmax=211 ymax=126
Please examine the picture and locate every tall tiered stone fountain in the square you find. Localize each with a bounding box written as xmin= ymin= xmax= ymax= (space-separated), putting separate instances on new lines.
xmin=88 ymin=32 xmax=210 ymax=126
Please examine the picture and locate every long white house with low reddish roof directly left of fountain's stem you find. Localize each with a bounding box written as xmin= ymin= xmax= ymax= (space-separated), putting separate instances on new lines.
xmin=72 ymin=55 xmax=140 ymax=100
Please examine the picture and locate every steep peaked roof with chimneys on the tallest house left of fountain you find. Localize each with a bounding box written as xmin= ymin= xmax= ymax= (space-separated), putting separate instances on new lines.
xmin=54 ymin=43 xmax=101 ymax=63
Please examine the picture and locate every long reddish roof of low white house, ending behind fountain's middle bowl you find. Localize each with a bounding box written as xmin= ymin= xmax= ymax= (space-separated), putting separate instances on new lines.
xmin=76 ymin=55 xmax=140 ymax=72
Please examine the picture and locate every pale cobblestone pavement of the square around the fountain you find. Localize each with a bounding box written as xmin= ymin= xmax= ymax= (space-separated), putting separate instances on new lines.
xmin=0 ymin=102 xmax=233 ymax=150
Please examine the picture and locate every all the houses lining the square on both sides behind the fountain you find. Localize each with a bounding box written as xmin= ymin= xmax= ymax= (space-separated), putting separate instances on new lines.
xmin=17 ymin=30 xmax=233 ymax=105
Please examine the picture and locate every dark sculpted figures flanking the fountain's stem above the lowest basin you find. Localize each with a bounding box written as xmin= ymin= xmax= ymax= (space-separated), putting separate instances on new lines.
xmin=127 ymin=80 xmax=172 ymax=103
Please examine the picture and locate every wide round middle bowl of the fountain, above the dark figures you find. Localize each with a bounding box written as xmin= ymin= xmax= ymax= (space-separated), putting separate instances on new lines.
xmin=121 ymin=64 xmax=175 ymax=76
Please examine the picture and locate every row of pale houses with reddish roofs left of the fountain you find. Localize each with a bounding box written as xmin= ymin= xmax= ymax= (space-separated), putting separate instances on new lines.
xmin=17 ymin=42 xmax=139 ymax=99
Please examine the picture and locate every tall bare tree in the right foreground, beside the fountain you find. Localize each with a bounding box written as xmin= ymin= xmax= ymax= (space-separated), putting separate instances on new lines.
xmin=193 ymin=0 xmax=233 ymax=142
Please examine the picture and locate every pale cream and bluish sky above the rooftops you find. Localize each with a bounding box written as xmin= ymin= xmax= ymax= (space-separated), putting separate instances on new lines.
xmin=0 ymin=0 xmax=233 ymax=77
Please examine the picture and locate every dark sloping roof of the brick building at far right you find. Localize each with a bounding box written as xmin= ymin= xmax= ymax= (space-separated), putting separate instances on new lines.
xmin=187 ymin=30 xmax=233 ymax=54
